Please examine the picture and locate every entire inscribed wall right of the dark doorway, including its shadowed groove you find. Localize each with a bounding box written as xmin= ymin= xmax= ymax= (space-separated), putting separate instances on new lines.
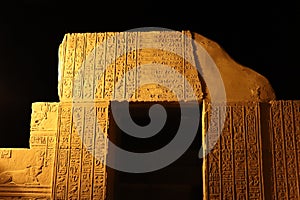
xmin=204 ymin=101 xmax=300 ymax=199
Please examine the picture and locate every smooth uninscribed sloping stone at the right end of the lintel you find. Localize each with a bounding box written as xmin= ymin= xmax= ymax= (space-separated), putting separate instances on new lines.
xmin=192 ymin=33 xmax=276 ymax=102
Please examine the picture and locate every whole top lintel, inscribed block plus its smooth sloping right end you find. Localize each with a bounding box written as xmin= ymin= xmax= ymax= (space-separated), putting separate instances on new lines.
xmin=59 ymin=31 xmax=275 ymax=101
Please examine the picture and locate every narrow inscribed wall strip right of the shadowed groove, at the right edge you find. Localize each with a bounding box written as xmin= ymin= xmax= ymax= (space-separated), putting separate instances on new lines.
xmin=270 ymin=101 xmax=300 ymax=199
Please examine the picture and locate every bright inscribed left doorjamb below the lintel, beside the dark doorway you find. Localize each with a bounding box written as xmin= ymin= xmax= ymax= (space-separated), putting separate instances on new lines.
xmin=53 ymin=102 xmax=109 ymax=200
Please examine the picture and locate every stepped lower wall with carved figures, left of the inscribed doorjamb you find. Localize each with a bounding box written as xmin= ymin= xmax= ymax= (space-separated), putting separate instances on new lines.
xmin=0 ymin=103 xmax=59 ymax=199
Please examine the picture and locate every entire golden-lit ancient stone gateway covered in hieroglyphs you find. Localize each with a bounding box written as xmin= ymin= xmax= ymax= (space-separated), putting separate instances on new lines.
xmin=0 ymin=31 xmax=300 ymax=199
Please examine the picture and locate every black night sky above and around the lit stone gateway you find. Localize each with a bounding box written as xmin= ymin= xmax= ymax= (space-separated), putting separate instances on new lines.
xmin=0 ymin=0 xmax=300 ymax=147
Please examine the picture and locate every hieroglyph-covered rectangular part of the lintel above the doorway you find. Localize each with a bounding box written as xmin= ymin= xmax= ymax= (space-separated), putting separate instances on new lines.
xmin=59 ymin=31 xmax=203 ymax=102
